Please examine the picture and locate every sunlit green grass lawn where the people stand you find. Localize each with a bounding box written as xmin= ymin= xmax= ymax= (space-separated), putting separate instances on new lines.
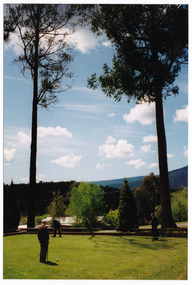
xmin=3 ymin=234 xmax=187 ymax=280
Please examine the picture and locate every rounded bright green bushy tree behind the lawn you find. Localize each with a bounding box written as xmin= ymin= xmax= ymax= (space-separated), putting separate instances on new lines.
xmin=69 ymin=182 xmax=105 ymax=228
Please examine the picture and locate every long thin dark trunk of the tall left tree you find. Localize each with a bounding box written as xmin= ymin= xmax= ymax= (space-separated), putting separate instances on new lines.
xmin=27 ymin=8 xmax=39 ymax=227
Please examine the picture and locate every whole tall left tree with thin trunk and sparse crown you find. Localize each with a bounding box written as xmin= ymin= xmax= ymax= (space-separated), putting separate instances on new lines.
xmin=4 ymin=4 xmax=77 ymax=227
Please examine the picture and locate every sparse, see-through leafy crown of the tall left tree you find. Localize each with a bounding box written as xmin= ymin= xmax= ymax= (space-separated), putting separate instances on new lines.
xmin=4 ymin=4 xmax=74 ymax=108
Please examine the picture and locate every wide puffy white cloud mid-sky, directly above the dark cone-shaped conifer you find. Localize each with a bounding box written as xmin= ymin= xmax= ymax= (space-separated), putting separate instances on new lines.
xmin=99 ymin=139 xmax=135 ymax=158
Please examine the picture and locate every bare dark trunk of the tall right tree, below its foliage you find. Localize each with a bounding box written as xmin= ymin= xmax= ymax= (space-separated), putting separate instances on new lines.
xmin=156 ymin=92 xmax=177 ymax=229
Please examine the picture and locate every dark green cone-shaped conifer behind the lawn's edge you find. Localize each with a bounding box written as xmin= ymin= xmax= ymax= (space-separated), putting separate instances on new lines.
xmin=119 ymin=179 xmax=137 ymax=231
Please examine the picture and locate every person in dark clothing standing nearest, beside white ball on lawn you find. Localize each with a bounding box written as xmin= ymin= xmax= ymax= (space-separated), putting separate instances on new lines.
xmin=38 ymin=221 xmax=49 ymax=262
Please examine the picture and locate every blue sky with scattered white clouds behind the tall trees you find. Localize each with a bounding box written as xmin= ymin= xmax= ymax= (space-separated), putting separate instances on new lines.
xmin=3 ymin=5 xmax=188 ymax=184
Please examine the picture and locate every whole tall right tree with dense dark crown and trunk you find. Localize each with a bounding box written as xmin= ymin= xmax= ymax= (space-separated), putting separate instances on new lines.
xmin=88 ymin=5 xmax=188 ymax=228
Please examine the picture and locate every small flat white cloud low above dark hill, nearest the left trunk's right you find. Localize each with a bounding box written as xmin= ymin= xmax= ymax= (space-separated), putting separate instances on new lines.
xmin=51 ymin=154 xmax=82 ymax=168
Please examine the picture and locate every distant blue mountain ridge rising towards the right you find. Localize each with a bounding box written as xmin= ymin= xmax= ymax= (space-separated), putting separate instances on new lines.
xmin=91 ymin=166 xmax=188 ymax=189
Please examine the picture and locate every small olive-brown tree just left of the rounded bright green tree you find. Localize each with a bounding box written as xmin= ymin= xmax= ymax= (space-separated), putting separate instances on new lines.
xmin=48 ymin=189 xmax=66 ymax=217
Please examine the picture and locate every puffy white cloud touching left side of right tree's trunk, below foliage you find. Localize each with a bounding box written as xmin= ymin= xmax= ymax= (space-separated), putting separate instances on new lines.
xmin=123 ymin=102 xmax=155 ymax=125
